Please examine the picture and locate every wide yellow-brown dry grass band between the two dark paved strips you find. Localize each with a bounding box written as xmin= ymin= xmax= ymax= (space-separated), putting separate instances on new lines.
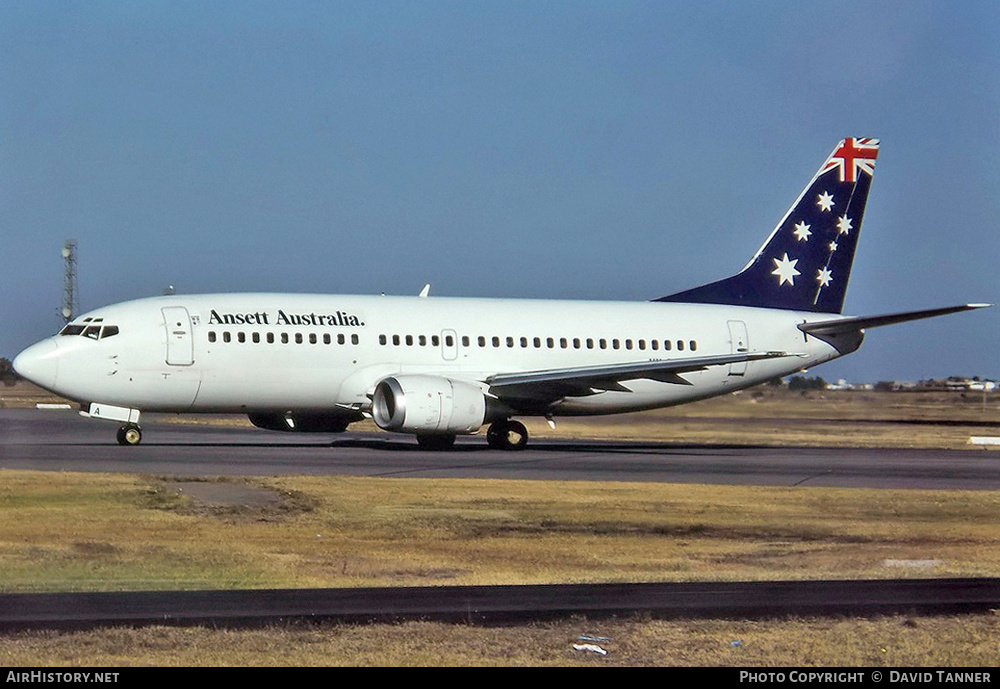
xmin=0 ymin=471 xmax=1000 ymax=591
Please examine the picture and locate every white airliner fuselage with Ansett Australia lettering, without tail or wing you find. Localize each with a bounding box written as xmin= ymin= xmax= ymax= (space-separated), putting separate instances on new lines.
xmin=18 ymin=294 xmax=846 ymax=415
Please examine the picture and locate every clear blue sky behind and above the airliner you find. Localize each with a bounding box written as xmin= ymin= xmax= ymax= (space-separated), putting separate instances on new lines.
xmin=0 ymin=0 xmax=1000 ymax=381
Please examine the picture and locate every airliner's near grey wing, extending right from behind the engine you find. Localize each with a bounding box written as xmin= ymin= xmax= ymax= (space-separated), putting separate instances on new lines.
xmin=485 ymin=352 xmax=796 ymax=400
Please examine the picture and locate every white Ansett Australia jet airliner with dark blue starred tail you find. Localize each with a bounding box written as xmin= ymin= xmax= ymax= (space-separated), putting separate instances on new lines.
xmin=13 ymin=137 xmax=989 ymax=450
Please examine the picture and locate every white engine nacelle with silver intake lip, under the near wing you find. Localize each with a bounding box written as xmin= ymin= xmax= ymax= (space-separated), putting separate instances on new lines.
xmin=372 ymin=375 xmax=486 ymax=434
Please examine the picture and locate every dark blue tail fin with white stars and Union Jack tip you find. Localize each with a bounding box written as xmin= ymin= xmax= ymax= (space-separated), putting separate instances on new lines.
xmin=655 ymin=138 xmax=878 ymax=313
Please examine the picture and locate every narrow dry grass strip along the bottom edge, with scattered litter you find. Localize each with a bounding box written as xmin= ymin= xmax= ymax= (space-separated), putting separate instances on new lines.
xmin=0 ymin=615 xmax=1000 ymax=668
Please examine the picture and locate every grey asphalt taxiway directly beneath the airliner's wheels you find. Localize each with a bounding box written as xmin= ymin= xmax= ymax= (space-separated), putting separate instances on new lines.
xmin=0 ymin=409 xmax=1000 ymax=490
